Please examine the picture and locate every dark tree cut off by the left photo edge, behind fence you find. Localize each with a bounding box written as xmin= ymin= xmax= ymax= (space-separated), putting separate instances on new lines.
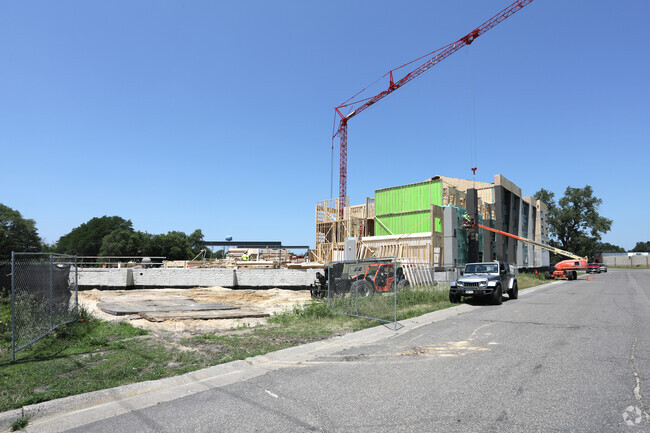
xmin=0 ymin=203 xmax=42 ymax=260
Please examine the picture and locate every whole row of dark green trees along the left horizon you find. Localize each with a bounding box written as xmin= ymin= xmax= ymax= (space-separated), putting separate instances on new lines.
xmin=0 ymin=204 xmax=203 ymax=260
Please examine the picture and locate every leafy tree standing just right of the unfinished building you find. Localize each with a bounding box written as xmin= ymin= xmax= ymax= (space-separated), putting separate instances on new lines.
xmin=535 ymin=185 xmax=612 ymax=256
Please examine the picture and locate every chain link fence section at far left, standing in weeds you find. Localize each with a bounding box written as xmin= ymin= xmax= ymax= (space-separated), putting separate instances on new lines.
xmin=11 ymin=252 xmax=79 ymax=360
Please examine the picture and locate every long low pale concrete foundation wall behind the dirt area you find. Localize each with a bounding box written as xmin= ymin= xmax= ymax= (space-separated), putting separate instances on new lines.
xmin=78 ymin=268 xmax=323 ymax=289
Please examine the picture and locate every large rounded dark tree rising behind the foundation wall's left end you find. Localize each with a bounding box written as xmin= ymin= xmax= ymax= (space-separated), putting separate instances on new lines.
xmin=56 ymin=215 xmax=133 ymax=256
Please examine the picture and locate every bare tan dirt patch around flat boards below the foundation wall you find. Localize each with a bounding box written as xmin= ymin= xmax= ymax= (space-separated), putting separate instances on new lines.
xmin=79 ymin=287 xmax=311 ymax=340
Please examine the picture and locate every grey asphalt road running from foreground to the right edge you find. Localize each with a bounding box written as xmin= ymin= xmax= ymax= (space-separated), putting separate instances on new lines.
xmin=28 ymin=270 xmax=650 ymax=433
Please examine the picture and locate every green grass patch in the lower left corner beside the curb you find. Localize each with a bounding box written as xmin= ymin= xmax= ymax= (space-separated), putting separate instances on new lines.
xmin=0 ymin=302 xmax=214 ymax=411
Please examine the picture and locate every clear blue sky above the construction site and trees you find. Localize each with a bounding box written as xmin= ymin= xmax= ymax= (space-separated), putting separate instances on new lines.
xmin=0 ymin=0 xmax=650 ymax=249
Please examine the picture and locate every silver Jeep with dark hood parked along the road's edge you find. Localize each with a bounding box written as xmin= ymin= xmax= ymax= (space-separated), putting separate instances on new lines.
xmin=449 ymin=262 xmax=519 ymax=305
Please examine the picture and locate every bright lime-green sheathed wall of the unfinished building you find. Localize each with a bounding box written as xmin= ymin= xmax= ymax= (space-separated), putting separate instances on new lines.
xmin=375 ymin=180 xmax=442 ymax=236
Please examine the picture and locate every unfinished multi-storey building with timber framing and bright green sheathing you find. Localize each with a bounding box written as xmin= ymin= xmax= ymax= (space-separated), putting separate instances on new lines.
xmin=313 ymin=174 xmax=549 ymax=268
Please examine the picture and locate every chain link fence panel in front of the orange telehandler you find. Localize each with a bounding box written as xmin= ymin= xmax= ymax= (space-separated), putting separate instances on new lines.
xmin=327 ymin=257 xmax=448 ymax=329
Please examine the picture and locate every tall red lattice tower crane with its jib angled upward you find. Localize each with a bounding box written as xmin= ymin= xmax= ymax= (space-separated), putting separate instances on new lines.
xmin=332 ymin=0 xmax=533 ymax=209
